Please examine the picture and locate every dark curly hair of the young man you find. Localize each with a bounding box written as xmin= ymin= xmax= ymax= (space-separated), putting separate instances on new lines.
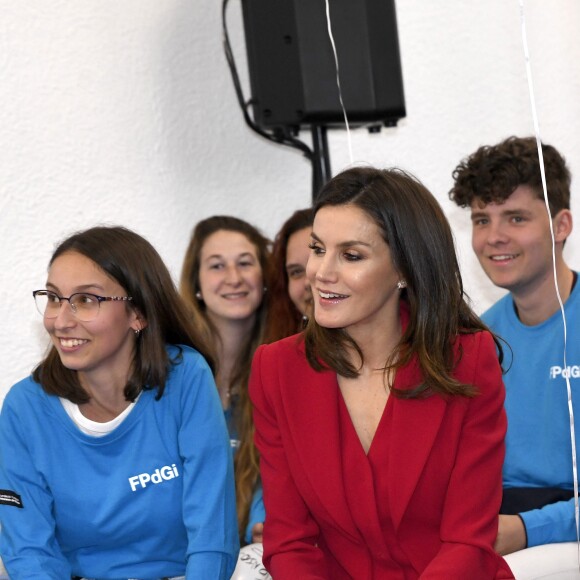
xmin=449 ymin=137 xmax=572 ymax=215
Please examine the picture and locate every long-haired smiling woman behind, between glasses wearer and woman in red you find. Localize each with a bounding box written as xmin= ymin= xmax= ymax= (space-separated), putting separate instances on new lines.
xmin=181 ymin=216 xmax=270 ymax=543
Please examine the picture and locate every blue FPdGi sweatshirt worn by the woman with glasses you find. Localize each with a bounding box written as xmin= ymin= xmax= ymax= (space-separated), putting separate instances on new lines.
xmin=0 ymin=347 xmax=239 ymax=580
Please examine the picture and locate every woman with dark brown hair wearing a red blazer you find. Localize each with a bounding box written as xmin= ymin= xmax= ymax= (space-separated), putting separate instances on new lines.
xmin=250 ymin=167 xmax=513 ymax=580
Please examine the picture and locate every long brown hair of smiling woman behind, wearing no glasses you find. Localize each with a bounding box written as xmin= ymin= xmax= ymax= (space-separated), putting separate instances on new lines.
xmin=180 ymin=216 xmax=270 ymax=541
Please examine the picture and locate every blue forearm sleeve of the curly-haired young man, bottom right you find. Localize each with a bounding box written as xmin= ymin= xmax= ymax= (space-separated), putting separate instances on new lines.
xmin=519 ymin=498 xmax=576 ymax=548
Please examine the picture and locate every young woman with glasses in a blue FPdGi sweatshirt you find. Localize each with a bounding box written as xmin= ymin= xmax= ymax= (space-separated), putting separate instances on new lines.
xmin=0 ymin=227 xmax=239 ymax=580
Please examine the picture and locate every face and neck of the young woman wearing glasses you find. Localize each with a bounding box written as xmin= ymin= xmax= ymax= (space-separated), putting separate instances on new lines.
xmin=37 ymin=251 xmax=142 ymax=406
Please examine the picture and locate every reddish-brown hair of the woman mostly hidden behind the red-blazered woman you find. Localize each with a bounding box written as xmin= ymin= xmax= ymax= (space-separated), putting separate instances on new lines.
xmin=265 ymin=208 xmax=314 ymax=342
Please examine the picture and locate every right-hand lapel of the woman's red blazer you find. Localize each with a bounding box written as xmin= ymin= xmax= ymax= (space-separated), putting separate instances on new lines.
xmin=389 ymin=362 xmax=447 ymax=531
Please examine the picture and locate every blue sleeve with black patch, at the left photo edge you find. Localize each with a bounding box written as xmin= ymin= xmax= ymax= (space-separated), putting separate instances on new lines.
xmin=0 ymin=382 xmax=71 ymax=580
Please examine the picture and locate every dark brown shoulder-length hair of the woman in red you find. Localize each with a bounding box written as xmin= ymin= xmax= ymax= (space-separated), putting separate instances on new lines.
xmin=305 ymin=167 xmax=501 ymax=398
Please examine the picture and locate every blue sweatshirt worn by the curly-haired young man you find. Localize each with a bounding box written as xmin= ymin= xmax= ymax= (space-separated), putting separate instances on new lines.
xmin=482 ymin=282 xmax=580 ymax=547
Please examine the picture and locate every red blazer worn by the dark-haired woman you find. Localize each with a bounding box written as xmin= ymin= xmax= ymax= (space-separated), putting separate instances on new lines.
xmin=250 ymin=332 xmax=513 ymax=580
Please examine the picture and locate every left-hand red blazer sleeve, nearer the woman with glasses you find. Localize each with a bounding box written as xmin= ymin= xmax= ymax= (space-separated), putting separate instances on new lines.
xmin=249 ymin=344 xmax=329 ymax=580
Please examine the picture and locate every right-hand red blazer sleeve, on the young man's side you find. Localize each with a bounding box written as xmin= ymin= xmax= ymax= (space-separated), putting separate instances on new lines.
xmin=421 ymin=332 xmax=513 ymax=580
